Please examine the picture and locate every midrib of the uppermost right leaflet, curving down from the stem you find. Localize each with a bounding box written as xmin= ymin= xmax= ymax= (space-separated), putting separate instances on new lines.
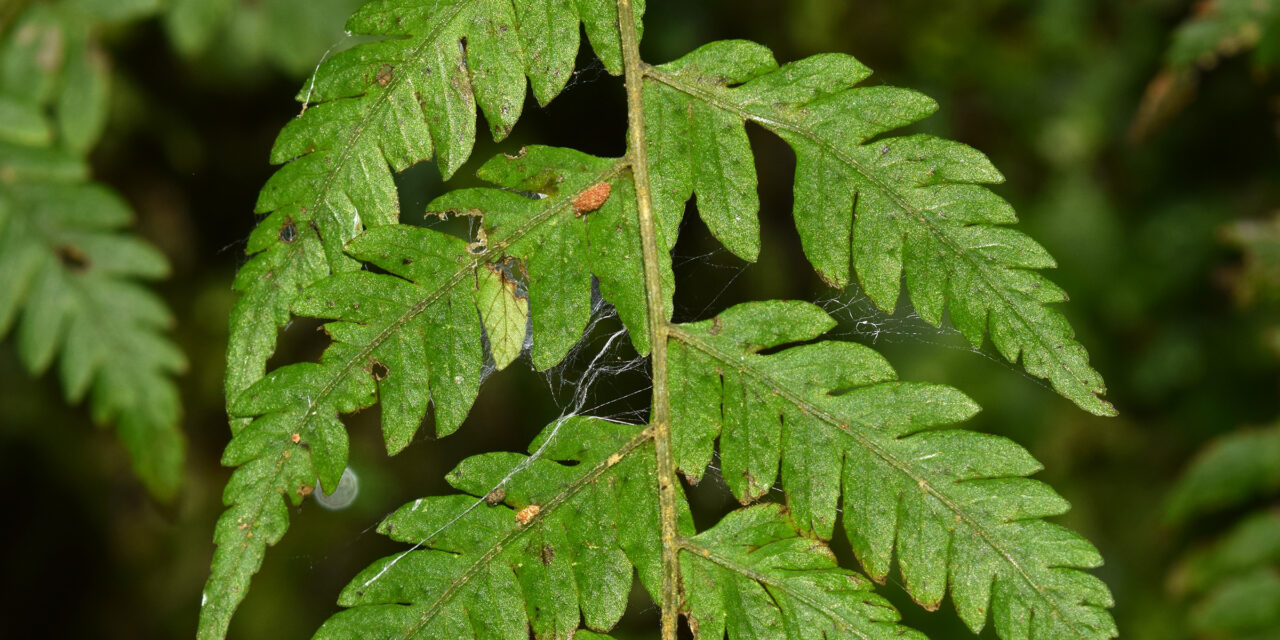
xmin=645 ymin=65 xmax=1107 ymax=407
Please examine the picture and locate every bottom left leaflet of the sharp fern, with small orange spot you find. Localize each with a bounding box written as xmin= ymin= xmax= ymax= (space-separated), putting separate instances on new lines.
xmin=316 ymin=417 xmax=665 ymax=639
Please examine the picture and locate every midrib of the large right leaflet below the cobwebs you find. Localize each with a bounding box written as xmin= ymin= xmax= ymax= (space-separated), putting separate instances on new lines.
xmin=669 ymin=325 xmax=1087 ymax=639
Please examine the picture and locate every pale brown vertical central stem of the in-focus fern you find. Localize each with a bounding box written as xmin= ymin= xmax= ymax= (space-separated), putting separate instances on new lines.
xmin=617 ymin=0 xmax=680 ymax=640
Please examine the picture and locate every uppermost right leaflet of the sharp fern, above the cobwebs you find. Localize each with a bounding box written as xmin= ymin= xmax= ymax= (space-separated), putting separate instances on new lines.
xmin=645 ymin=41 xmax=1115 ymax=415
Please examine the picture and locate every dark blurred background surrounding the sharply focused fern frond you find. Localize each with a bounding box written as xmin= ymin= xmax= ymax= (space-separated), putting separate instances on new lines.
xmin=0 ymin=0 xmax=1280 ymax=639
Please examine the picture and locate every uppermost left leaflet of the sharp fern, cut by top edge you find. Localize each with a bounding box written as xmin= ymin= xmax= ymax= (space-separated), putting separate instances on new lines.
xmin=227 ymin=0 xmax=643 ymax=414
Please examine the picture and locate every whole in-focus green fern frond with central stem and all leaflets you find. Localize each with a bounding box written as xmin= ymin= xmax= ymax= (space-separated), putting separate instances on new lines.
xmin=200 ymin=0 xmax=1115 ymax=640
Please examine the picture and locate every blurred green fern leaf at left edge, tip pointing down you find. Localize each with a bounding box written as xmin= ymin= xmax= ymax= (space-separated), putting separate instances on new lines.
xmin=0 ymin=177 xmax=186 ymax=499
